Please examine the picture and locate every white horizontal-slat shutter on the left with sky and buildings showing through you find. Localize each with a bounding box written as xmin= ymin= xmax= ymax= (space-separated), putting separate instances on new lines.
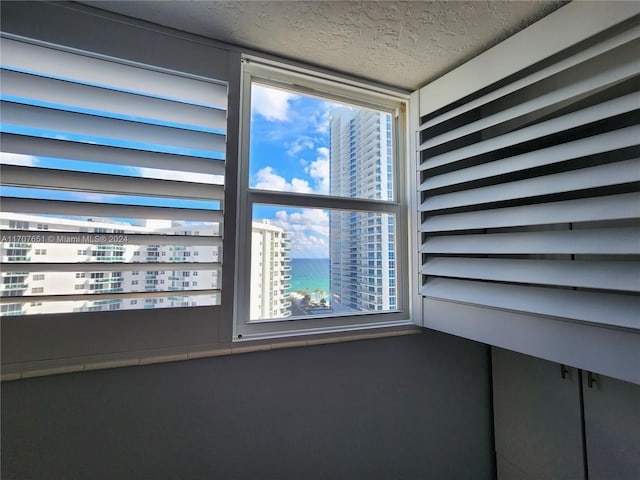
xmin=0 ymin=38 xmax=227 ymax=315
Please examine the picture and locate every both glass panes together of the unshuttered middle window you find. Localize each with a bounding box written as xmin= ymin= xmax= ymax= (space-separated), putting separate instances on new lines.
xmin=248 ymin=81 xmax=400 ymax=322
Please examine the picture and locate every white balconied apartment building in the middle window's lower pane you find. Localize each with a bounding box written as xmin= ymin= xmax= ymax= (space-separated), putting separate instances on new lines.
xmin=249 ymin=219 xmax=291 ymax=320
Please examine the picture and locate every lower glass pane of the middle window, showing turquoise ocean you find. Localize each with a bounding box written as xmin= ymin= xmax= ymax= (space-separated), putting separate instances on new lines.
xmin=251 ymin=205 xmax=397 ymax=320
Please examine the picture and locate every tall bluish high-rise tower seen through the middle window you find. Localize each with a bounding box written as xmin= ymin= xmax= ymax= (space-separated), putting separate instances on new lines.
xmin=329 ymin=108 xmax=397 ymax=313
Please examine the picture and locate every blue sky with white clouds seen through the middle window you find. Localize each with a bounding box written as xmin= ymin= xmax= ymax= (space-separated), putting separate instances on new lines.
xmin=249 ymin=84 xmax=340 ymax=258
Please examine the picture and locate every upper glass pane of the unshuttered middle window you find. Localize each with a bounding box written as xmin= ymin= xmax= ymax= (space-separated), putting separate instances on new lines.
xmin=249 ymin=83 xmax=394 ymax=200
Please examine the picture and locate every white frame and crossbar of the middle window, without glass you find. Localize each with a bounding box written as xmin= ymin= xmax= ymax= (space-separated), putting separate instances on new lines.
xmin=232 ymin=55 xmax=413 ymax=342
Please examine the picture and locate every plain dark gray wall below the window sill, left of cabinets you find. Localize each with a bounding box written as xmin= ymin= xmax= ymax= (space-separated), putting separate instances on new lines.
xmin=2 ymin=332 xmax=494 ymax=480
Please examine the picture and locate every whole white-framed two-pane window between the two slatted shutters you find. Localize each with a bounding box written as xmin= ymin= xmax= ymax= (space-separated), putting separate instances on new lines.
xmin=236 ymin=59 xmax=408 ymax=338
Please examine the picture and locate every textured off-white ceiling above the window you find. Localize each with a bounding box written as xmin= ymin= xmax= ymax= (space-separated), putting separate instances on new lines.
xmin=80 ymin=0 xmax=565 ymax=90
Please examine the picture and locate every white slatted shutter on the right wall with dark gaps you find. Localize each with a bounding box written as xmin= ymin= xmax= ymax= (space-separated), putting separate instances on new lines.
xmin=417 ymin=5 xmax=640 ymax=378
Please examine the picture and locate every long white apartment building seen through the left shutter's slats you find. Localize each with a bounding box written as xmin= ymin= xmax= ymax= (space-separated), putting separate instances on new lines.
xmin=0 ymin=212 xmax=221 ymax=316
